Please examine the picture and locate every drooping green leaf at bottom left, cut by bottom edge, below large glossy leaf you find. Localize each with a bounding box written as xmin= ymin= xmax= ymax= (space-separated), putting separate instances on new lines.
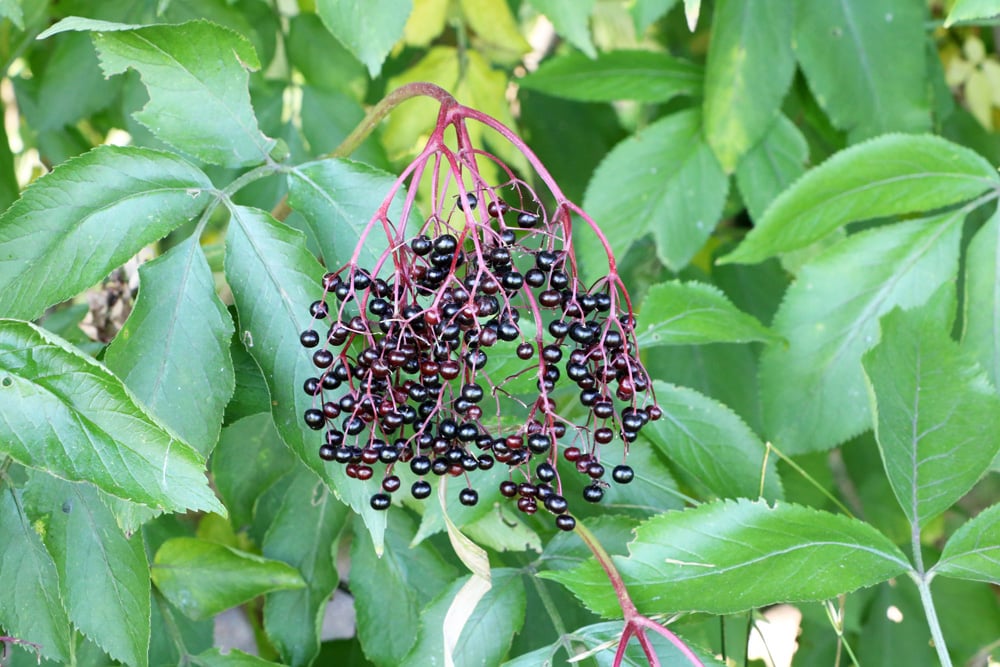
xmin=25 ymin=475 xmax=150 ymax=667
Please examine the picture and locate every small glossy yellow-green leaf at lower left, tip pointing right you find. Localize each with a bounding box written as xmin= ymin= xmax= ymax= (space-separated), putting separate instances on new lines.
xmin=151 ymin=537 xmax=306 ymax=621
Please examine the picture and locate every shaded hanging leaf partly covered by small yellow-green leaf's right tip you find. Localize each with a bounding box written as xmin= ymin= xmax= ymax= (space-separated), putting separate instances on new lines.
xmin=261 ymin=466 xmax=350 ymax=667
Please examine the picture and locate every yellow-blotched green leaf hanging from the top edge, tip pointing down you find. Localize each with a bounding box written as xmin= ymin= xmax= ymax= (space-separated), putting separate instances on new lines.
xmin=703 ymin=0 xmax=795 ymax=173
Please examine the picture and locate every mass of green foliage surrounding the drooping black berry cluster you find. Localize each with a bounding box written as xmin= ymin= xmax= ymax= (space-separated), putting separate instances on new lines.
xmin=0 ymin=0 xmax=1000 ymax=667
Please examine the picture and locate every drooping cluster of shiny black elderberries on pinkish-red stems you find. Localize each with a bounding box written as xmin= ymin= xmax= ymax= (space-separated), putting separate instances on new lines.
xmin=301 ymin=85 xmax=661 ymax=530
